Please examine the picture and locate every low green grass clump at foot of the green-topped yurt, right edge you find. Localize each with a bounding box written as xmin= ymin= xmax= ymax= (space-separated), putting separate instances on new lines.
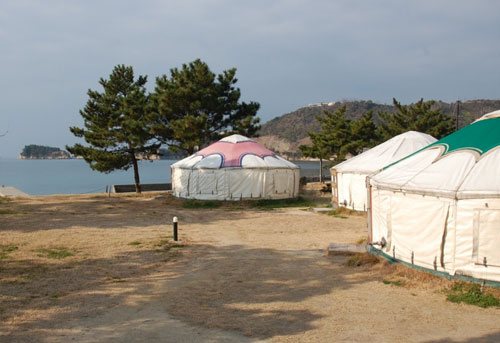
xmin=446 ymin=282 xmax=500 ymax=308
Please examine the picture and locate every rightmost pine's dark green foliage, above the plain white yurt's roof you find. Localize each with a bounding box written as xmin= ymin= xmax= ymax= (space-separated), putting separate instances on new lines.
xmin=378 ymin=99 xmax=455 ymax=141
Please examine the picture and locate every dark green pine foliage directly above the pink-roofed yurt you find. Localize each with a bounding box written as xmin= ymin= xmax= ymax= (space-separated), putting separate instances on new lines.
xmin=153 ymin=59 xmax=260 ymax=154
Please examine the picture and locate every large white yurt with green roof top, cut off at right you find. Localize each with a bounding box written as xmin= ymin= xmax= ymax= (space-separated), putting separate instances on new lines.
xmin=368 ymin=111 xmax=500 ymax=282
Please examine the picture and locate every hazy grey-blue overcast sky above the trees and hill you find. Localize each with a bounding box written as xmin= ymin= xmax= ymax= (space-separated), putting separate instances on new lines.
xmin=0 ymin=0 xmax=500 ymax=158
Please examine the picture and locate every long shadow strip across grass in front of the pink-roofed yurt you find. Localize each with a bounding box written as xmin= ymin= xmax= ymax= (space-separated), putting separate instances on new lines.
xmin=0 ymin=196 xmax=276 ymax=234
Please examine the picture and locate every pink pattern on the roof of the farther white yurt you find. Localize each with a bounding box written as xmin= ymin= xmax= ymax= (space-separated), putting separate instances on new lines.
xmin=196 ymin=140 xmax=276 ymax=168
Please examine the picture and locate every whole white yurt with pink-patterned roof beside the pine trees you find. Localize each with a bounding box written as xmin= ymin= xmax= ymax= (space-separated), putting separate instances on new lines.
xmin=171 ymin=135 xmax=300 ymax=200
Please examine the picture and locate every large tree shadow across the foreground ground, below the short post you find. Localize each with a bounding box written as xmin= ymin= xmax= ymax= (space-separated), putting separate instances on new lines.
xmin=0 ymin=241 xmax=369 ymax=342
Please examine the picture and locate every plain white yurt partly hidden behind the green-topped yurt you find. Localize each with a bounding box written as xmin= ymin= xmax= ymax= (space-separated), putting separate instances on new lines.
xmin=330 ymin=131 xmax=436 ymax=211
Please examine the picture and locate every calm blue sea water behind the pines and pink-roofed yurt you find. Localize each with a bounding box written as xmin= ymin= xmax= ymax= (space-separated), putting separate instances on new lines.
xmin=0 ymin=158 xmax=328 ymax=195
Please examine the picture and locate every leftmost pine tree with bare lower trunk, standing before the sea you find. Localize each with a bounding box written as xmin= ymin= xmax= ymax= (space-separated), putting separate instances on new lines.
xmin=66 ymin=65 xmax=159 ymax=193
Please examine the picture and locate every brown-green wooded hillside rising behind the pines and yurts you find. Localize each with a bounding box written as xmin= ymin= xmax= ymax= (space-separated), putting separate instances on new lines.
xmin=258 ymin=100 xmax=500 ymax=157
